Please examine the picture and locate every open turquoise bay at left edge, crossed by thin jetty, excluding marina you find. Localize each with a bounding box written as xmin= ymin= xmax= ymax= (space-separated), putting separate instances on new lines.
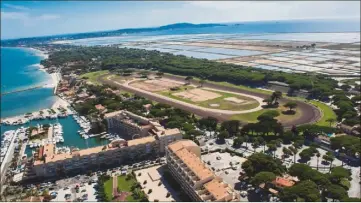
xmin=1 ymin=48 xmax=56 ymax=118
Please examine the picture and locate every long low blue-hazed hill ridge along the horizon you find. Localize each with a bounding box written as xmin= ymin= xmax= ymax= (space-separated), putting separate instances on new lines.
xmin=1 ymin=23 xmax=228 ymax=46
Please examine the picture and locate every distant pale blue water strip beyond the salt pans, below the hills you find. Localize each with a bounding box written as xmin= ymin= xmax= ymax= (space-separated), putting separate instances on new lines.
xmin=66 ymin=19 xmax=360 ymax=46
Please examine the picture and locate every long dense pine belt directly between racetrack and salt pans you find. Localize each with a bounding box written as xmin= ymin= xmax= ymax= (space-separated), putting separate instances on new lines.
xmin=43 ymin=47 xmax=337 ymax=95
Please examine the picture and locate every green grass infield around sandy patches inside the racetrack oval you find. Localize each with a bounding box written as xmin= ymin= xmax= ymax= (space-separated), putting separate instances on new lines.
xmin=158 ymin=86 xmax=259 ymax=111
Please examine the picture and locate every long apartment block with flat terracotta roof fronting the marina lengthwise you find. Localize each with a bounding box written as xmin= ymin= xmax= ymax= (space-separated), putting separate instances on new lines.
xmin=33 ymin=128 xmax=182 ymax=177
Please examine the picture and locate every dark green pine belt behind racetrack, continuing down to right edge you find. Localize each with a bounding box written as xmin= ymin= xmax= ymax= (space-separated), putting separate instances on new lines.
xmin=41 ymin=47 xmax=359 ymax=124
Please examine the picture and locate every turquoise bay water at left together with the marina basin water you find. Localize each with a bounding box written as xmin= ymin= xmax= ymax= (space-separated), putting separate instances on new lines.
xmin=1 ymin=48 xmax=108 ymax=151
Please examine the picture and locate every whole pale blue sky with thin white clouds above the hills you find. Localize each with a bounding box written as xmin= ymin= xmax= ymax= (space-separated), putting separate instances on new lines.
xmin=1 ymin=0 xmax=360 ymax=39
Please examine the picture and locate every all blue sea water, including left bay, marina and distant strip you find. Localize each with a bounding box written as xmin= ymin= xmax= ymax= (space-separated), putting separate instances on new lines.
xmin=1 ymin=19 xmax=360 ymax=153
